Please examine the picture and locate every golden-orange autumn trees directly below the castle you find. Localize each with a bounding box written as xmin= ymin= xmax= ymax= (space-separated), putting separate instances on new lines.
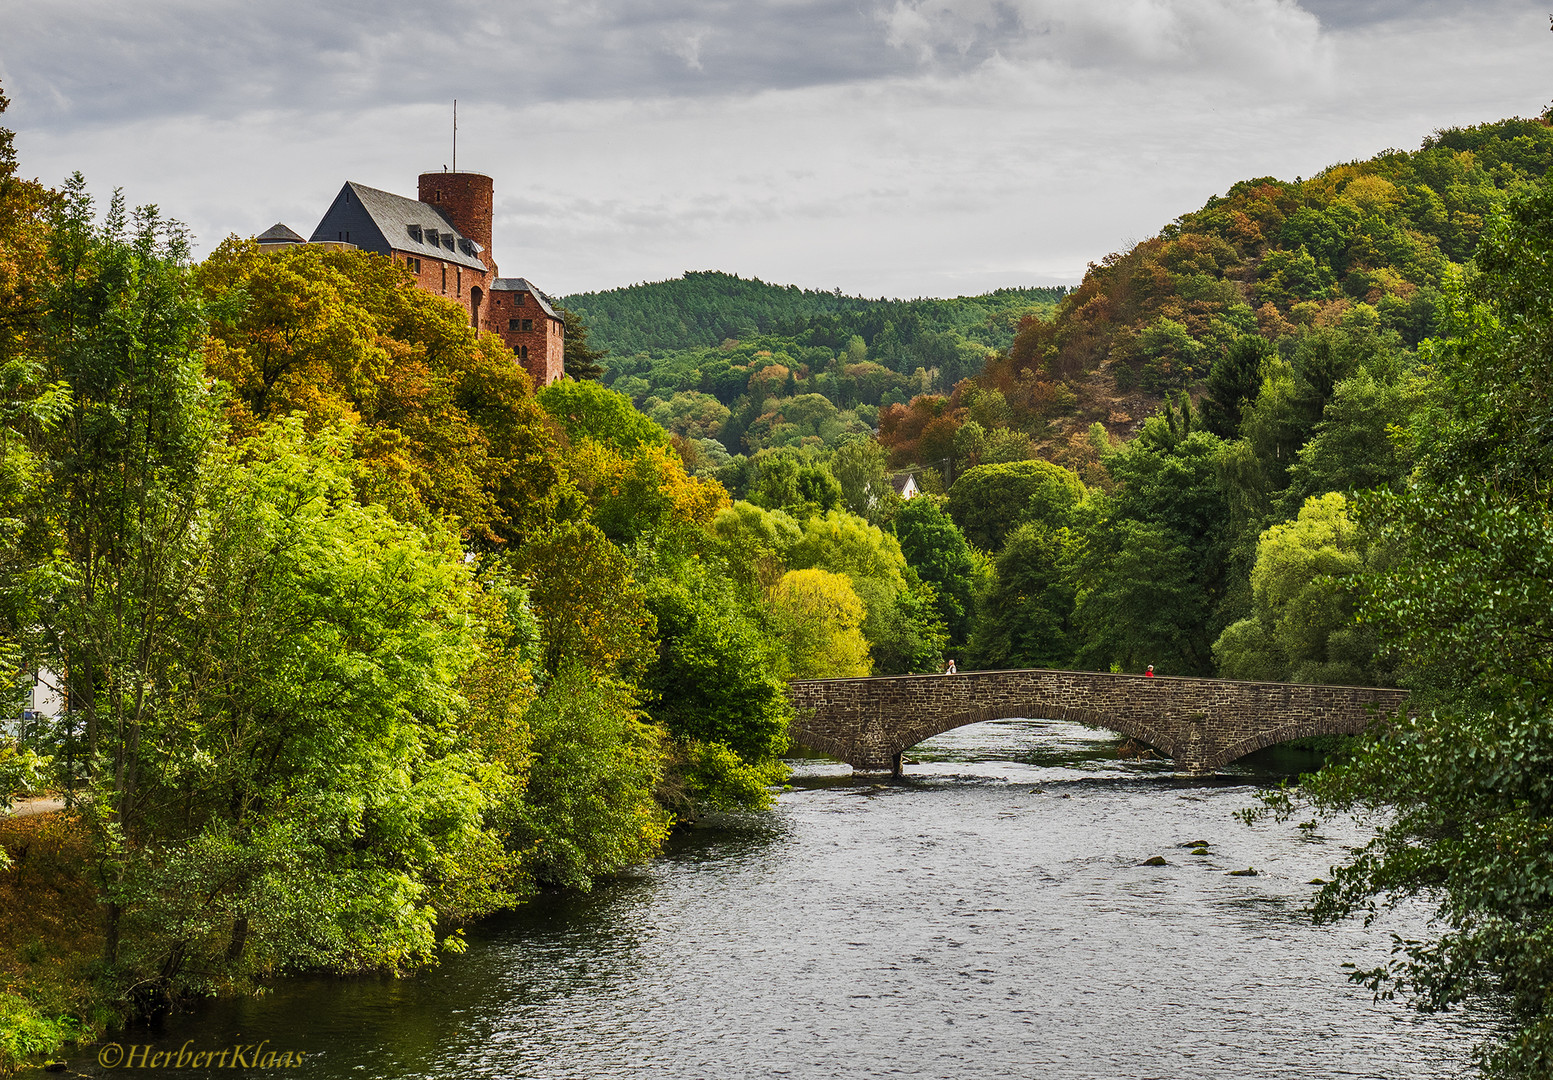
xmin=196 ymin=239 xmax=567 ymax=545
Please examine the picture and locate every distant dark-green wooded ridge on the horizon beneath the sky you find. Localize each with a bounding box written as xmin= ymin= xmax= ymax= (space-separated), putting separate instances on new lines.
xmin=561 ymin=270 xmax=1067 ymax=356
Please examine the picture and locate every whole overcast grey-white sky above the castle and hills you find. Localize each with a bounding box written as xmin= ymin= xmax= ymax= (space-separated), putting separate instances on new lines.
xmin=0 ymin=0 xmax=1553 ymax=297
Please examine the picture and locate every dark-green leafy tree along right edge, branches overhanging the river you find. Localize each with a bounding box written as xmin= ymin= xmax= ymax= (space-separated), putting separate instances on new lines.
xmin=1273 ymin=173 xmax=1553 ymax=1077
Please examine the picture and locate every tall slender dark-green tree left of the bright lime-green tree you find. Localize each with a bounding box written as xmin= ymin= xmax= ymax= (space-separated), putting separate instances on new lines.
xmin=28 ymin=174 xmax=217 ymax=965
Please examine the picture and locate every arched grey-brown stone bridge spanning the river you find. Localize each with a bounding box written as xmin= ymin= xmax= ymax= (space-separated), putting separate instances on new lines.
xmin=789 ymin=670 xmax=1407 ymax=772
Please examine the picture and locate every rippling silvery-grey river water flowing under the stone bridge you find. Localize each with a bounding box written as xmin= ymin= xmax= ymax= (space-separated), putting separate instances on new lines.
xmin=39 ymin=719 xmax=1483 ymax=1080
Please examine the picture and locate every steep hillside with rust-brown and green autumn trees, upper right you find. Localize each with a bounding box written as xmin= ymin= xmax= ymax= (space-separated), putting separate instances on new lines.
xmin=962 ymin=115 xmax=1553 ymax=444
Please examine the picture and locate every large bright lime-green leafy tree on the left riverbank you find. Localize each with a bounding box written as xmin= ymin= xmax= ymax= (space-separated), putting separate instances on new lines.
xmin=39 ymin=420 xmax=509 ymax=1007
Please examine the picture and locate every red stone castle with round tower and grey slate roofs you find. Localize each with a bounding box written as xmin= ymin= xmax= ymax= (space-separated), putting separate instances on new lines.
xmin=255 ymin=172 xmax=565 ymax=387
